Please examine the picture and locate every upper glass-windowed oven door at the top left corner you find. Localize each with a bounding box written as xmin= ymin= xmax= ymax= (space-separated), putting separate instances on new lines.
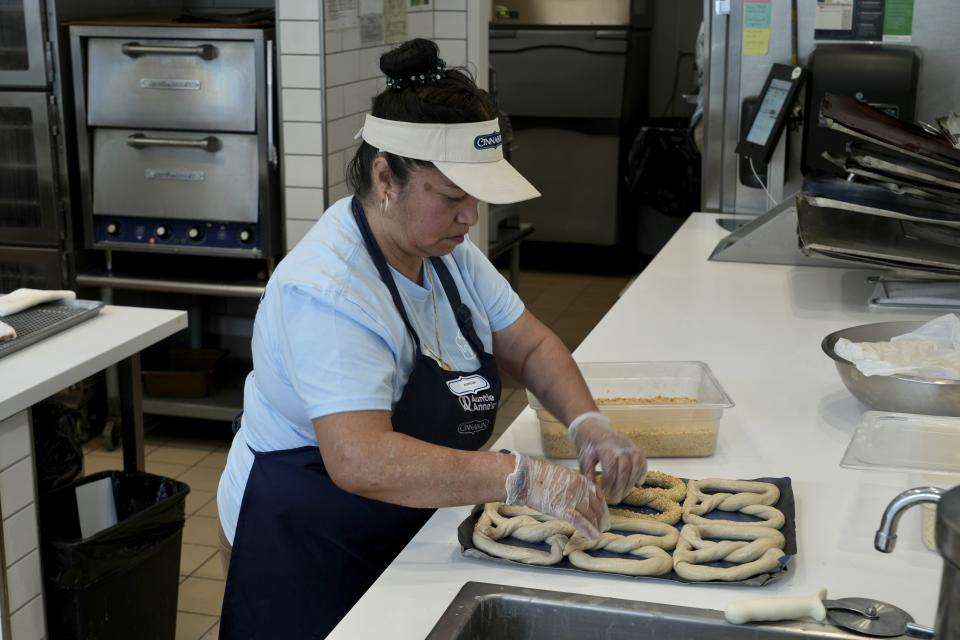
xmin=0 ymin=0 xmax=47 ymax=87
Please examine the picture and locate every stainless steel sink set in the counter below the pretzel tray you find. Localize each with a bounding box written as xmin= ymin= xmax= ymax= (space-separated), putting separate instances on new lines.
xmin=427 ymin=582 xmax=884 ymax=640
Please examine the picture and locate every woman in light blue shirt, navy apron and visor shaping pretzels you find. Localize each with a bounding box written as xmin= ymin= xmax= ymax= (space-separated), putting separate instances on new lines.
xmin=217 ymin=40 xmax=646 ymax=638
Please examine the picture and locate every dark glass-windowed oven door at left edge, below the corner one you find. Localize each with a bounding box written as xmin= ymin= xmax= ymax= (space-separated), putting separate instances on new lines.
xmin=0 ymin=91 xmax=62 ymax=246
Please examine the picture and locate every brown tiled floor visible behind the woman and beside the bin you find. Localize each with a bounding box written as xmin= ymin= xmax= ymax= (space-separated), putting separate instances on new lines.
xmin=77 ymin=271 xmax=629 ymax=640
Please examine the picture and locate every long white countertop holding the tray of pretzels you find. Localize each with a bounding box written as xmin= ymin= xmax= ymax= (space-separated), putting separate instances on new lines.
xmin=330 ymin=214 xmax=942 ymax=640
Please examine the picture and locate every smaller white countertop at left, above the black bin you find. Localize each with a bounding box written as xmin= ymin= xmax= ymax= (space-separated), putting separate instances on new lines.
xmin=0 ymin=305 xmax=187 ymax=420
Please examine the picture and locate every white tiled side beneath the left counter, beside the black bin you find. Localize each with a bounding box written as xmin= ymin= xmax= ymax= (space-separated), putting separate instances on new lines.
xmin=0 ymin=411 xmax=46 ymax=640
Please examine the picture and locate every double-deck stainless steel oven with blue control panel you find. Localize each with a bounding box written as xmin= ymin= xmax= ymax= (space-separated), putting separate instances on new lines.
xmin=70 ymin=25 xmax=280 ymax=258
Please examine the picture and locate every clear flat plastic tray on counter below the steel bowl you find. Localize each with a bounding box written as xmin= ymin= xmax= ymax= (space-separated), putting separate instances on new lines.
xmin=840 ymin=411 xmax=960 ymax=474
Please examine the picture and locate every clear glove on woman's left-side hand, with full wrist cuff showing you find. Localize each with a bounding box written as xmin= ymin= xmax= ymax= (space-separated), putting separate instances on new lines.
xmin=504 ymin=453 xmax=610 ymax=541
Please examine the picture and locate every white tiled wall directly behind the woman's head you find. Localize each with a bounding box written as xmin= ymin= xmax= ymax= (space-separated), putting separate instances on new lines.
xmin=277 ymin=0 xmax=480 ymax=250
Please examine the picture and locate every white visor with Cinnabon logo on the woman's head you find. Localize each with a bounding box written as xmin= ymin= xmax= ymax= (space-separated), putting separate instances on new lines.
xmin=357 ymin=115 xmax=540 ymax=204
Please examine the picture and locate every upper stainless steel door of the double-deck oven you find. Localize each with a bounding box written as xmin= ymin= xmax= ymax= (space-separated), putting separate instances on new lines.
xmin=87 ymin=37 xmax=257 ymax=132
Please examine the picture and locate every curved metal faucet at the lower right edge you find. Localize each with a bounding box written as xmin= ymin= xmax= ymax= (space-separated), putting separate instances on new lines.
xmin=873 ymin=486 xmax=960 ymax=640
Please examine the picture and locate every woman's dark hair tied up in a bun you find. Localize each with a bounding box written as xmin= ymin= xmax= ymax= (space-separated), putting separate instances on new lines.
xmin=347 ymin=38 xmax=497 ymax=199
